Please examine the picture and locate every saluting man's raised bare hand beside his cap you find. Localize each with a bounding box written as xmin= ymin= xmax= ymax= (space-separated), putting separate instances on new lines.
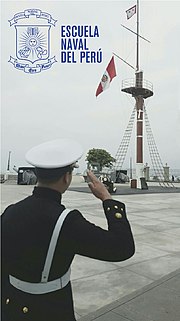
xmin=87 ymin=171 xmax=112 ymax=201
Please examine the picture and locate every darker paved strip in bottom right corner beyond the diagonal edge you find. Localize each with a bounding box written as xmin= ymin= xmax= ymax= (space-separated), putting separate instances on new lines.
xmin=79 ymin=269 xmax=180 ymax=321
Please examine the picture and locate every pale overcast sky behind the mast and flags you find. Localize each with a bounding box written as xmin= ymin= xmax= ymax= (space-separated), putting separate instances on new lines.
xmin=1 ymin=0 xmax=180 ymax=171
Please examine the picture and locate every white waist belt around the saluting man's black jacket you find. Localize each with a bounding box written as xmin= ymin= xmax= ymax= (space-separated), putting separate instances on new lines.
xmin=9 ymin=268 xmax=71 ymax=294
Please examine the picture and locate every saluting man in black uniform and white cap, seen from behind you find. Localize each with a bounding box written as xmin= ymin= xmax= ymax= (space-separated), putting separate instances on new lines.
xmin=2 ymin=139 xmax=135 ymax=321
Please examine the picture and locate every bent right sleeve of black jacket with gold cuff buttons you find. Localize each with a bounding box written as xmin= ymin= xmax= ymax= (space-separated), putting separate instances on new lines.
xmin=69 ymin=199 xmax=135 ymax=262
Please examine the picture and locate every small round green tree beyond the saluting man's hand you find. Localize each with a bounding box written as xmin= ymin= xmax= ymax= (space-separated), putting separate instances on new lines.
xmin=86 ymin=148 xmax=115 ymax=171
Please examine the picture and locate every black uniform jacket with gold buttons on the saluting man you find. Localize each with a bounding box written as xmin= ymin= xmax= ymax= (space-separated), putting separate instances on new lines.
xmin=2 ymin=187 xmax=134 ymax=321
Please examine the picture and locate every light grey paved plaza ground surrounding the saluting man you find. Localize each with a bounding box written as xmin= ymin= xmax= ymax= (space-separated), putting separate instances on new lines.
xmin=1 ymin=176 xmax=180 ymax=321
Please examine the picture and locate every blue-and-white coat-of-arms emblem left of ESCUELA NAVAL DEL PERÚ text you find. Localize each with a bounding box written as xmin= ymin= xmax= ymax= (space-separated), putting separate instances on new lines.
xmin=9 ymin=9 xmax=57 ymax=74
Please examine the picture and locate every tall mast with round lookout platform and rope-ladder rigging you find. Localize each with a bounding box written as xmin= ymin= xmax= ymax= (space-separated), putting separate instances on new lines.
xmin=115 ymin=0 xmax=174 ymax=189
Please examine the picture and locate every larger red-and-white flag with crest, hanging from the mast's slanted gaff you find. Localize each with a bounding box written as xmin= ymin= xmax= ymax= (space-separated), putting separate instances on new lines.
xmin=96 ymin=56 xmax=116 ymax=97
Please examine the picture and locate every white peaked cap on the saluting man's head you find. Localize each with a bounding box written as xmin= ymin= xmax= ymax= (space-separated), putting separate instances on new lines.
xmin=25 ymin=138 xmax=83 ymax=169
